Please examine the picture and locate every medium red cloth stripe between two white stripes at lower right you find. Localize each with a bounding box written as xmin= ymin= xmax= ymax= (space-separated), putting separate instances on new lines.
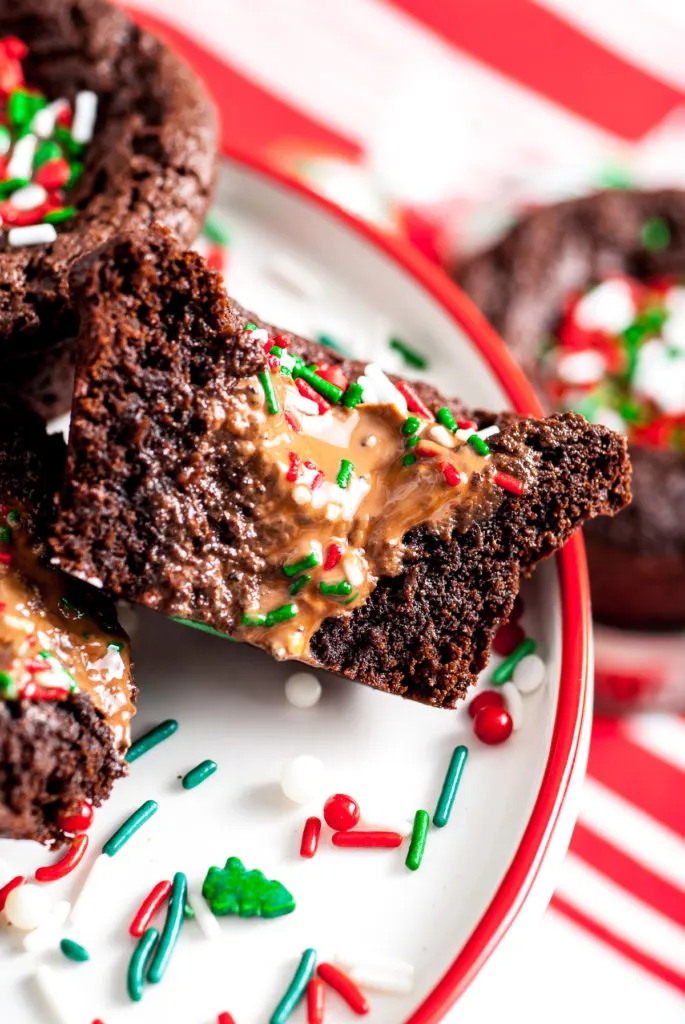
xmin=570 ymin=823 xmax=685 ymax=927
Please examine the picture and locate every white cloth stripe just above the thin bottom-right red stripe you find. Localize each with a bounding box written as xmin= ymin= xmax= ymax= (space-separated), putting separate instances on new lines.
xmin=557 ymin=853 xmax=685 ymax=975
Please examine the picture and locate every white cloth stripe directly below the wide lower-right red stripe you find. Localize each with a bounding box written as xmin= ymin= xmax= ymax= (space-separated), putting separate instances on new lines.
xmin=580 ymin=778 xmax=685 ymax=889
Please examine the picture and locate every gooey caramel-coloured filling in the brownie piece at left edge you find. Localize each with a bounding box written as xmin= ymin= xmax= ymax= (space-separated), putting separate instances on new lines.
xmin=0 ymin=512 xmax=134 ymax=755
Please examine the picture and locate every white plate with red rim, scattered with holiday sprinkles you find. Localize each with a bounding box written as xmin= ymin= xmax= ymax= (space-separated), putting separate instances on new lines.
xmin=0 ymin=153 xmax=589 ymax=1024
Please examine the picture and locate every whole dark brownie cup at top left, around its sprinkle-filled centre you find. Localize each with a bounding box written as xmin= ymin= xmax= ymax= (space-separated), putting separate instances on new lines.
xmin=0 ymin=0 xmax=217 ymax=416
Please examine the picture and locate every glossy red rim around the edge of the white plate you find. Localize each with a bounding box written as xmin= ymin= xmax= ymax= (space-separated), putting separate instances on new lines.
xmin=125 ymin=10 xmax=591 ymax=1024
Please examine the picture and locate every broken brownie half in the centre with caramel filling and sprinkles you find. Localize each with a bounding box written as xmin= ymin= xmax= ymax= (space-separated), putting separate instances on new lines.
xmin=53 ymin=230 xmax=630 ymax=708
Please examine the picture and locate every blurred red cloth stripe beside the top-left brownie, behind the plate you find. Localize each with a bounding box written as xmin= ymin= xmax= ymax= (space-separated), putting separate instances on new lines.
xmin=128 ymin=9 xmax=361 ymax=159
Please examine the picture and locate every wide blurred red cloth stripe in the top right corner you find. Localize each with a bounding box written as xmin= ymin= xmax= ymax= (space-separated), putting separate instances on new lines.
xmin=384 ymin=0 xmax=683 ymax=139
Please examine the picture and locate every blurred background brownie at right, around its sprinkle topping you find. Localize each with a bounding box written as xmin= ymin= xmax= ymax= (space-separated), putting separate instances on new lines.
xmin=455 ymin=188 xmax=685 ymax=629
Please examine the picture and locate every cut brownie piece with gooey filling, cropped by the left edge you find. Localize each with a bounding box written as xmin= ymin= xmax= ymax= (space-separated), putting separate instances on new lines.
xmin=0 ymin=391 xmax=136 ymax=843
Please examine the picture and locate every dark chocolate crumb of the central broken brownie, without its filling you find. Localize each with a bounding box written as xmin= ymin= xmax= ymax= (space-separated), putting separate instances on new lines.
xmin=52 ymin=230 xmax=630 ymax=707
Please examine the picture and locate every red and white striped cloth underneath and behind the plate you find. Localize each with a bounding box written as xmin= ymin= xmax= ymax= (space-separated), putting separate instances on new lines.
xmin=127 ymin=0 xmax=685 ymax=1024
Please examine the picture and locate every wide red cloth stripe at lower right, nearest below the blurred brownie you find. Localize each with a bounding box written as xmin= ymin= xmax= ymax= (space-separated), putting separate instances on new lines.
xmin=588 ymin=719 xmax=685 ymax=838
